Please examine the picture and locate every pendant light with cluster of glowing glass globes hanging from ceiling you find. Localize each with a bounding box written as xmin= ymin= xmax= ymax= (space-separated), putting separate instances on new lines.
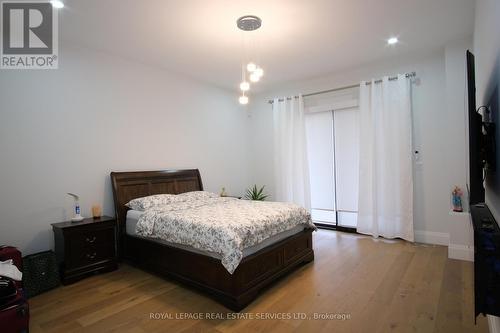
xmin=236 ymin=15 xmax=264 ymax=105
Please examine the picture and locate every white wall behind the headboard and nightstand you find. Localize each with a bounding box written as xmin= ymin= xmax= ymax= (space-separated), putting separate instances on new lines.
xmin=0 ymin=43 xmax=248 ymax=254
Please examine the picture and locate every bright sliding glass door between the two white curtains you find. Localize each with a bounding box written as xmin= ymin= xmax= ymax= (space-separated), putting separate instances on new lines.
xmin=306 ymin=107 xmax=359 ymax=228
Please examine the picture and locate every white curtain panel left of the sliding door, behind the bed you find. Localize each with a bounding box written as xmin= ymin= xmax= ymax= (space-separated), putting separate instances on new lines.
xmin=273 ymin=96 xmax=311 ymax=210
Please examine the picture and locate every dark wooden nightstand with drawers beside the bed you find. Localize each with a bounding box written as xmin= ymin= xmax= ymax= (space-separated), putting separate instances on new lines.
xmin=52 ymin=216 xmax=118 ymax=284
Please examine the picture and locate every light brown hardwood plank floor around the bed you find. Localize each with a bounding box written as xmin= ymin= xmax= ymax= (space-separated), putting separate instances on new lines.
xmin=30 ymin=230 xmax=488 ymax=333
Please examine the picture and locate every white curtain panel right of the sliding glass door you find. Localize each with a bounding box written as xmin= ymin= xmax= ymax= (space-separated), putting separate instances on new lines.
xmin=357 ymin=75 xmax=414 ymax=241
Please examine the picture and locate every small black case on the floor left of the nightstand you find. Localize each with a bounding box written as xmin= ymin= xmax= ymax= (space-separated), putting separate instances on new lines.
xmin=23 ymin=251 xmax=61 ymax=298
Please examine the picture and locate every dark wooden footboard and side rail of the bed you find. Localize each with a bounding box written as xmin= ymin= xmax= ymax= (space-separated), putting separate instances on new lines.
xmin=124 ymin=230 xmax=314 ymax=311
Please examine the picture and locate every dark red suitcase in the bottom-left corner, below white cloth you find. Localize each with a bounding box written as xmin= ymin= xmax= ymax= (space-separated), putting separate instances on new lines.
xmin=0 ymin=279 xmax=29 ymax=333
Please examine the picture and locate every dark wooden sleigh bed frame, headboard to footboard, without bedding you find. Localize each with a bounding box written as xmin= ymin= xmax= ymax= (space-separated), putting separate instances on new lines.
xmin=111 ymin=169 xmax=314 ymax=311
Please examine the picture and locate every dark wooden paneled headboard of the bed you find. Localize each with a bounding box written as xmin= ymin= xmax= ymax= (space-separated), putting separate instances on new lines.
xmin=111 ymin=169 xmax=203 ymax=246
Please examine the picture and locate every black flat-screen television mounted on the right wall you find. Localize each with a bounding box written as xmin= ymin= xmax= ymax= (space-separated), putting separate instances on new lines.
xmin=467 ymin=51 xmax=485 ymax=205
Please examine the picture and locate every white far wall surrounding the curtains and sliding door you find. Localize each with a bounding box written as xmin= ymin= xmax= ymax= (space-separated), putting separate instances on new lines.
xmin=250 ymin=45 xmax=470 ymax=245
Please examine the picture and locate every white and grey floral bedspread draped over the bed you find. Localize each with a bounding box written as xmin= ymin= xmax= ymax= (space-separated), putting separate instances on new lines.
xmin=136 ymin=197 xmax=315 ymax=274
